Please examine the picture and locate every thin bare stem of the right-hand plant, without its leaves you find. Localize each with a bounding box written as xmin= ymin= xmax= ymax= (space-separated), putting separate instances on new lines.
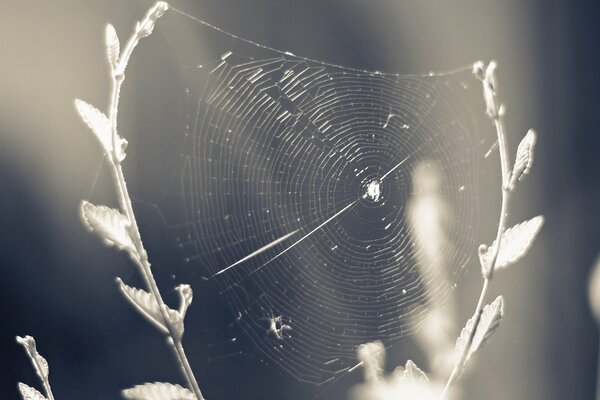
xmin=441 ymin=65 xmax=511 ymax=399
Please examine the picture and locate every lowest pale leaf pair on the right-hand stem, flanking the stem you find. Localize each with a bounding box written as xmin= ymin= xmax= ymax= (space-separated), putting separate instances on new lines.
xmin=454 ymin=296 xmax=504 ymax=363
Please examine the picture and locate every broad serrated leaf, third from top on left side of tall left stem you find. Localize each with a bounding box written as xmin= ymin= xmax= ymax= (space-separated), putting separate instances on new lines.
xmin=81 ymin=200 xmax=137 ymax=257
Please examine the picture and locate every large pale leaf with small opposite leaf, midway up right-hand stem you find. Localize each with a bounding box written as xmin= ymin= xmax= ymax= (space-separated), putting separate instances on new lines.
xmin=479 ymin=215 xmax=544 ymax=275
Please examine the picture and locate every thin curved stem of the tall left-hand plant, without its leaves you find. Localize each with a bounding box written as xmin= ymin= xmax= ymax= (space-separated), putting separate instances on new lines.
xmin=103 ymin=2 xmax=204 ymax=400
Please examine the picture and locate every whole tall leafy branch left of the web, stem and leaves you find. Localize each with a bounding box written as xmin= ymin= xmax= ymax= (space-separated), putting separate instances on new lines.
xmin=75 ymin=1 xmax=204 ymax=400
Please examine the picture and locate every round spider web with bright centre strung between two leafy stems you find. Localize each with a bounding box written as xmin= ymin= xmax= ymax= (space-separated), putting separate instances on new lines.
xmin=152 ymin=7 xmax=481 ymax=384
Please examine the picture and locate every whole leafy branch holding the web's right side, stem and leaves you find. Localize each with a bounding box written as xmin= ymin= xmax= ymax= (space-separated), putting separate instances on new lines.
xmin=442 ymin=61 xmax=544 ymax=398
